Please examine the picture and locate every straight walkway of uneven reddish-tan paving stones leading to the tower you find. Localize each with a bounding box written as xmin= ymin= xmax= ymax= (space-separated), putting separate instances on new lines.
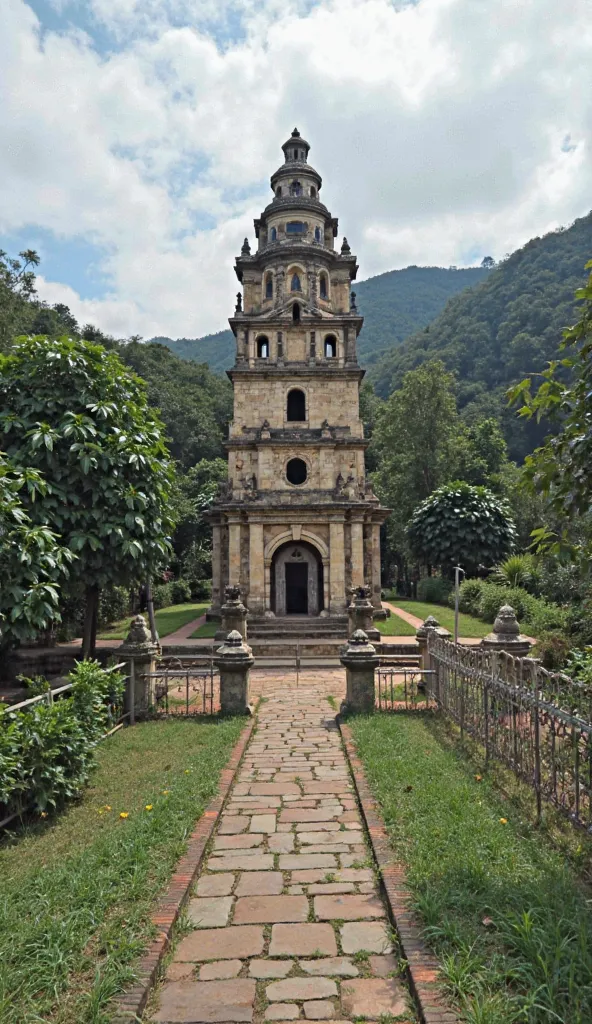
xmin=152 ymin=677 xmax=416 ymax=1024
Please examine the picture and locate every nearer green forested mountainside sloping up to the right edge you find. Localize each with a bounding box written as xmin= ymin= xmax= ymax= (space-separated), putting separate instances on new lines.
xmin=370 ymin=213 xmax=592 ymax=459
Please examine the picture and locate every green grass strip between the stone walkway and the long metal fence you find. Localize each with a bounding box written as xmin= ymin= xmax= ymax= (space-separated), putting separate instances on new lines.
xmin=350 ymin=714 xmax=592 ymax=1024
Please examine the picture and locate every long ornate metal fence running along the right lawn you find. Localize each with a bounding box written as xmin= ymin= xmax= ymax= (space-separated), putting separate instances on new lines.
xmin=426 ymin=631 xmax=592 ymax=830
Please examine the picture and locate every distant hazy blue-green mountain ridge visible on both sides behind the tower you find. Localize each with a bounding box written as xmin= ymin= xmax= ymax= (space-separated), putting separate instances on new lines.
xmin=152 ymin=266 xmax=483 ymax=373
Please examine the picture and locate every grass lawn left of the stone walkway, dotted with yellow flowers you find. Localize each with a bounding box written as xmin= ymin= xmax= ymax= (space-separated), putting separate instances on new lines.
xmin=0 ymin=718 xmax=245 ymax=1024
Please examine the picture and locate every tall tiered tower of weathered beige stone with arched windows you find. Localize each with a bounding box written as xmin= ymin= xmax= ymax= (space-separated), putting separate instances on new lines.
xmin=206 ymin=129 xmax=388 ymax=622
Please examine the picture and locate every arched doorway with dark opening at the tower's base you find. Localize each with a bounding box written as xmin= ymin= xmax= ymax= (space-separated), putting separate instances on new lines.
xmin=270 ymin=541 xmax=324 ymax=616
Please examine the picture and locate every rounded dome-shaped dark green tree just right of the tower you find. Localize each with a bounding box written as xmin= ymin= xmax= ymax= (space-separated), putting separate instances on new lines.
xmin=407 ymin=481 xmax=515 ymax=575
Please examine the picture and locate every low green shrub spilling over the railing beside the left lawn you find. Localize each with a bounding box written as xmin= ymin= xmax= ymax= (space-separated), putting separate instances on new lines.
xmin=0 ymin=662 xmax=124 ymax=817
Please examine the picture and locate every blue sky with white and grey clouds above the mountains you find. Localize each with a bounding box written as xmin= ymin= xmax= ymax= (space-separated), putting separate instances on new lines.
xmin=0 ymin=0 xmax=592 ymax=337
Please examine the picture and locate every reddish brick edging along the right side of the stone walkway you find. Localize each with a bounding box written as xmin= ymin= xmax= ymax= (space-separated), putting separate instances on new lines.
xmin=337 ymin=717 xmax=460 ymax=1024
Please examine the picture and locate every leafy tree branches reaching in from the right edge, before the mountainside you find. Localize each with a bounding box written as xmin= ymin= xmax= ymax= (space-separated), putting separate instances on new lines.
xmin=510 ymin=260 xmax=592 ymax=558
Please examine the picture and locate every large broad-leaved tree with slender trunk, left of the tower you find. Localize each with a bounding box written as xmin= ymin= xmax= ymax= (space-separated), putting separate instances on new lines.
xmin=0 ymin=337 xmax=173 ymax=655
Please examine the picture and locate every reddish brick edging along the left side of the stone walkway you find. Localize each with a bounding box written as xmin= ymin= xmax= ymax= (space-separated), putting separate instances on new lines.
xmin=113 ymin=717 xmax=256 ymax=1024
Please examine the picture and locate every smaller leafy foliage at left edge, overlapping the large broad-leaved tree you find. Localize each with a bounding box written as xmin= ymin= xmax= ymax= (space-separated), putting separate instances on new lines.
xmin=0 ymin=454 xmax=74 ymax=649
